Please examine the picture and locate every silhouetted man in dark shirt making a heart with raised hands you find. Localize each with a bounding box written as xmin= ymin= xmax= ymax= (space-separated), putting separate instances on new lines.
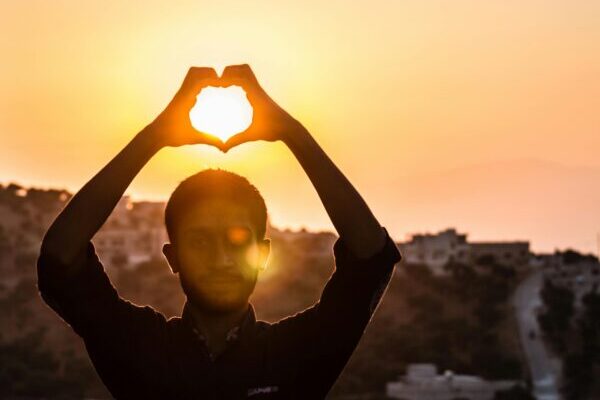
xmin=38 ymin=65 xmax=400 ymax=399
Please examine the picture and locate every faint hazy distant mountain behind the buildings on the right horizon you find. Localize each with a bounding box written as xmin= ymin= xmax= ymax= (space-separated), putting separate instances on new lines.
xmin=386 ymin=159 xmax=600 ymax=253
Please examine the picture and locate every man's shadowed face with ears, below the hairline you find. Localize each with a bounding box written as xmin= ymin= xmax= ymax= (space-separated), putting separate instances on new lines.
xmin=165 ymin=199 xmax=269 ymax=312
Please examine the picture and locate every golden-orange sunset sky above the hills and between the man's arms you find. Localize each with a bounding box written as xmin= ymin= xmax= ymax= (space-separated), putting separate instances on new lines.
xmin=0 ymin=0 xmax=600 ymax=252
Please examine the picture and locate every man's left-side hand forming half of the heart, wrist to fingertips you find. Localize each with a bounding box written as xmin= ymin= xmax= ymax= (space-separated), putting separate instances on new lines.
xmin=145 ymin=67 xmax=224 ymax=150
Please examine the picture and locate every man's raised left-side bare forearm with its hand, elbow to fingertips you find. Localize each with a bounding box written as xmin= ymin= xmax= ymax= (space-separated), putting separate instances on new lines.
xmin=41 ymin=67 xmax=222 ymax=272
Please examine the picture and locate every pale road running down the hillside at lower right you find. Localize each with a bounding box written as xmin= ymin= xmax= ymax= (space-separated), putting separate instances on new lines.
xmin=513 ymin=271 xmax=561 ymax=400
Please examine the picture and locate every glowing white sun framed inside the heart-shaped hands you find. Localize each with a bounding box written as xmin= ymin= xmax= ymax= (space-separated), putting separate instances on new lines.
xmin=190 ymin=86 xmax=252 ymax=141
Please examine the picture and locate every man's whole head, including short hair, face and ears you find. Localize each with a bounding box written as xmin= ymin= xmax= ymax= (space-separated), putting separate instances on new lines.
xmin=163 ymin=170 xmax=270 ymax=313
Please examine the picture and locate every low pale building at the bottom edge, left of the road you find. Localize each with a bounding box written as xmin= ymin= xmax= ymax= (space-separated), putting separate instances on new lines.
xmin=386 ymin=364 xmax=518 ymax=400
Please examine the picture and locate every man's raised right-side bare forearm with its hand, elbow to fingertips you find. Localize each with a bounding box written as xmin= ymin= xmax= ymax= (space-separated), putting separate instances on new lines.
xmin=222 ymin=65 xmax=386 ymax=258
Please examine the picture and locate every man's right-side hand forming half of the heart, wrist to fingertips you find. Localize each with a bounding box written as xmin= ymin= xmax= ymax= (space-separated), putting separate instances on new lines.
xmin=219 ymin=64 xmax=303 ymax=151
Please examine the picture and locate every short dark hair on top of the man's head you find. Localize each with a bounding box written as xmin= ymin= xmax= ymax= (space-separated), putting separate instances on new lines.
xmin=165 ymin=169 xmax=267 ymax=242
